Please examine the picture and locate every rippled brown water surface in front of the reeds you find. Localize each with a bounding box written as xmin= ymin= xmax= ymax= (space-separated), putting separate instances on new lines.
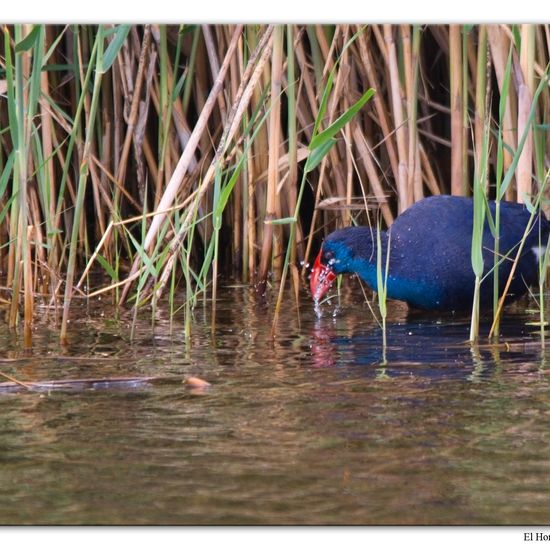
xmin=0 ymin=288 xmax=550 ymax=525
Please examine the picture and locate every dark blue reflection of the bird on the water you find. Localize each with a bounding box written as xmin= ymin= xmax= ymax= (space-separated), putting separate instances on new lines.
xmin=311 ymin=317 xmax=542 ymax=379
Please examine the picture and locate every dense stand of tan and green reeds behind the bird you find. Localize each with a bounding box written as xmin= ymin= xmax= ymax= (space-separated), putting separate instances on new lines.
xmin=0 ymin=24 xmax=550 ymax=339
